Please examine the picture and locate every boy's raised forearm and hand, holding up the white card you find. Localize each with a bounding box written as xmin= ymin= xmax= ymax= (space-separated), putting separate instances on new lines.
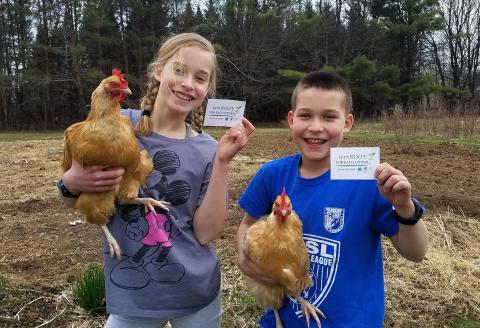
xmin=375 ymin=163 xmax=428 ymax=262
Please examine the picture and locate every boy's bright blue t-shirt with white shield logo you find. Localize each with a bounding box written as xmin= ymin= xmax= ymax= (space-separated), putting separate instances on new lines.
xmin=239 ymin=154 xmax=399 ymax=328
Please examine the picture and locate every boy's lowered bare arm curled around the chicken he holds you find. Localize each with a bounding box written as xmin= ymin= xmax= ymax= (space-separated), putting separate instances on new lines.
xmin=237 ymin=213 xmax=276 ymax=285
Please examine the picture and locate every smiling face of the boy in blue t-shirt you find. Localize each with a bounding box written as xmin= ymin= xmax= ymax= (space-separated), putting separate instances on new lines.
xmin=288 ymin=87 xmax=353 ymax=172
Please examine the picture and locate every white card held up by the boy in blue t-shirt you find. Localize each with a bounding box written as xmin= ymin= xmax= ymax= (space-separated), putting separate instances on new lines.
xmin=330 ymin=147 xmax=380 ymax=180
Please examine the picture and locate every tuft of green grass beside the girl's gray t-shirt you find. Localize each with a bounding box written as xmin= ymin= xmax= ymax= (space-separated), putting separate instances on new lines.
xmin=73 ymin=263 xmax=106 ymax=316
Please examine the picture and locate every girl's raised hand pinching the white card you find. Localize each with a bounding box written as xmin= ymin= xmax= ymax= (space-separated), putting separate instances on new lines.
xmin=217 ymin=117 xmax=255 ymax=163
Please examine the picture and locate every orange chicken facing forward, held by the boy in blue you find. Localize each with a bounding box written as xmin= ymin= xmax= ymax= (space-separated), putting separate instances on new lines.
xmin=243 ymin=188 xmax=325 ymax=328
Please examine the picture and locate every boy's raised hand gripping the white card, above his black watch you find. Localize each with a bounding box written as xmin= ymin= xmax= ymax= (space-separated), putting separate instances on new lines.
xmin=374 ymin=162 xmax=415 ymax=214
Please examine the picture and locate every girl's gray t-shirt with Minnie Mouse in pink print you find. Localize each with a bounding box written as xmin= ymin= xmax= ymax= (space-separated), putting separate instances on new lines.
xmin=104 ymin=110 xmax=221 ymax=318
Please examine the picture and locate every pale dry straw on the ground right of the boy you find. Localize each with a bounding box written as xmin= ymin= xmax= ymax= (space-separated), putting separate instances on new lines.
xmin=384 ymin=211 xmax=480 ymax=327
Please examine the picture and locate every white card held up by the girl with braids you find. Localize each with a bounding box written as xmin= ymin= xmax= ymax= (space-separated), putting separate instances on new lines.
xmin=203 ymin=99 xmax=245 ymax=127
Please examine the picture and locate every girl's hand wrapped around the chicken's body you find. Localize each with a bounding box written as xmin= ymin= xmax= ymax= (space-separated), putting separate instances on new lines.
xmin=62 ymin=160 xmax=124 ymax=194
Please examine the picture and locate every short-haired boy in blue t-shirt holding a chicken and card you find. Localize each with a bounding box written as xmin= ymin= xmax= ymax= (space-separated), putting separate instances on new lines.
xmin=237 ymin=72 xmax=428 ymax=328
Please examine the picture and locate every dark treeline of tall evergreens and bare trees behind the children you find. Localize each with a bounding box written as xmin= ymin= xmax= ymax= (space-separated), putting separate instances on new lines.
xmin=0 ymin=0 xmax=480 ymax=130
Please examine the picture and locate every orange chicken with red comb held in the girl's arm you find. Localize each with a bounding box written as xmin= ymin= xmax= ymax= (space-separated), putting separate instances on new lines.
xmin=60 ymin=69 xmax=166 ymax=259
